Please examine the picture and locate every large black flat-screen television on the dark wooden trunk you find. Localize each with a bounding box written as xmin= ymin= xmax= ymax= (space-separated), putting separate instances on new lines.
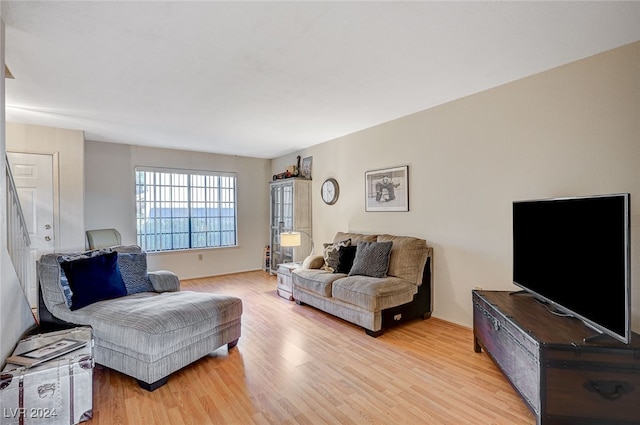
xmin=513 ymin=193 xmax=631 ymax=344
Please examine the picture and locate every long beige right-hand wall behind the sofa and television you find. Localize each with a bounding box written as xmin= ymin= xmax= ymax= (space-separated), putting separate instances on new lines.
xmin=272 ymin=42 xmax=640 ymax=331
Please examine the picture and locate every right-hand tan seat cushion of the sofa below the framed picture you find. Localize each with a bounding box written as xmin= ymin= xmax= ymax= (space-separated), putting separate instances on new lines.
xmin=331 ymin=276 xmax=418 ymax=311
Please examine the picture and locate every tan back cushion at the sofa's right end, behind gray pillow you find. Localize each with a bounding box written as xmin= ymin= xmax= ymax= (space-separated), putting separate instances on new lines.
xmin=378 ymin=235 xmax=429 ymax=285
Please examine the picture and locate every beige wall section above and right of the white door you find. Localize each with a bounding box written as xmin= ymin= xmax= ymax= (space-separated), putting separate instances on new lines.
xmin=7 ymin=122 xmax=85 ymax=252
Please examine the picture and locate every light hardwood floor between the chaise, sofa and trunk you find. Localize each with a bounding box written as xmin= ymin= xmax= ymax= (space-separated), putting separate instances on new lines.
xmin=86 ymin=271 xmax=535 ymax=425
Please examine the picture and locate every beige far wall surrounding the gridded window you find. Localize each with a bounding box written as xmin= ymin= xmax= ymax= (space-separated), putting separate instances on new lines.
xmin=85 ymin=141 xmax=271 ymax=279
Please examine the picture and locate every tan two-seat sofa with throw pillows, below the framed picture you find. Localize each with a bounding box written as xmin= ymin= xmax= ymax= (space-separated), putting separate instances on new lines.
xmin=292 ymin=232 xmax=433 ymax=337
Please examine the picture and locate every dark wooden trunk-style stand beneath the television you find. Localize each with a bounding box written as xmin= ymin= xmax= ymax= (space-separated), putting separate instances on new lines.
xmin=473 ymin=291 xmax=640 ymax=425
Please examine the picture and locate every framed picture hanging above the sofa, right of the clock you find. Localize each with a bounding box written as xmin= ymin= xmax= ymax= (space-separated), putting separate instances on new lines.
xmin=364 ymin=165 xmax=409 ymax=211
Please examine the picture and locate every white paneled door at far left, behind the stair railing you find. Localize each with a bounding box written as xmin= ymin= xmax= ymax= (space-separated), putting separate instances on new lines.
xmin=7 ymin=152 xmax=56 ymax=308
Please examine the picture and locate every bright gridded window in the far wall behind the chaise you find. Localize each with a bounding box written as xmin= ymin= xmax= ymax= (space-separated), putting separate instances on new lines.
xmin=136 ymin=167 xmax=237 ymax=251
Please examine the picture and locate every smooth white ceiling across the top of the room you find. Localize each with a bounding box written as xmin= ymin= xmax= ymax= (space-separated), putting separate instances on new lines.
xmin=2 ymin=1 xmax=640 ymax=158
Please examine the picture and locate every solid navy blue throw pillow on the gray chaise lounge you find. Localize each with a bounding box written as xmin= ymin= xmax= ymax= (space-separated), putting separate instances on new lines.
xmin=60 ymin=251 xmax=127 ymax=310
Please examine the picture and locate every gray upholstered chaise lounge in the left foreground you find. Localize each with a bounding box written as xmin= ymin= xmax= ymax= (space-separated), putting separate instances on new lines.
xmin=38 ymin=245 xmax=242 ymax=391
